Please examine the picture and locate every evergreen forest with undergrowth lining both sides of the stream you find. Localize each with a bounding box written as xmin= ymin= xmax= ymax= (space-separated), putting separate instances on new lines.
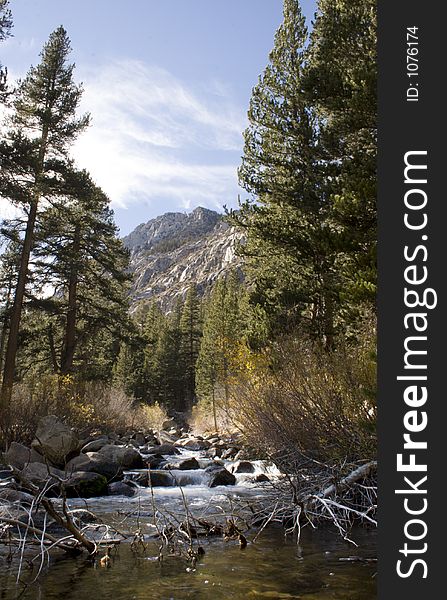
xmin=0 ymin=0 xmax=377 ymax=468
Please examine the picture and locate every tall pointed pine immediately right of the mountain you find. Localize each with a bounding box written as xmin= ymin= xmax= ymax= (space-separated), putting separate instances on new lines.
xmin=232 ymin=0 xmax=338 ymax=346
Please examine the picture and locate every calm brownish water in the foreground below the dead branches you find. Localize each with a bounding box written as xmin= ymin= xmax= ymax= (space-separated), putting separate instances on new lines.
xmin=0 ymin=528 xmax=376 ymax=600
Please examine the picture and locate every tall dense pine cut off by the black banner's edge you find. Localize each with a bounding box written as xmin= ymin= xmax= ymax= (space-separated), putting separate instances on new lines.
xmin=306 ymin=0 xmax=377 ymax=305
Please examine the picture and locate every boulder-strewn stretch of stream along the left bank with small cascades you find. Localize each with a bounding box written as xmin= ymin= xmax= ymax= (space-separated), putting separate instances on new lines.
xmin=0 ymin=415 xmax=269 ymax=503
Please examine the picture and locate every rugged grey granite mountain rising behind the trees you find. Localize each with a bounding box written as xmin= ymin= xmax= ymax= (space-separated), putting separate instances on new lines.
xmin=123 ymin=207 xmax=242 ymax=310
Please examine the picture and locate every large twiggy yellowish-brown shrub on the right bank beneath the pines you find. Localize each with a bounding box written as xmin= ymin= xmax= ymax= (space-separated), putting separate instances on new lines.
xmin=230 ymin=318 xmax=376 ymax=461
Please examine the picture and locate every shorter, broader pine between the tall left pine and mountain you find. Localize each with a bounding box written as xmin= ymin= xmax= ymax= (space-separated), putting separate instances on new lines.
xmin=33 ymin=167 xmax=131 ymax=375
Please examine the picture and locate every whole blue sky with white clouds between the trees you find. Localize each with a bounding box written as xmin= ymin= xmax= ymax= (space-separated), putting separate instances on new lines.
xmin=0 ymin=0 xmax=315 ymax=234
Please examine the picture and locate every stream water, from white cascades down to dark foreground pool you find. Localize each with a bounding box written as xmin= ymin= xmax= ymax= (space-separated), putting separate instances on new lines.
xmin=0 ymin=442 xmax=376 ymax=600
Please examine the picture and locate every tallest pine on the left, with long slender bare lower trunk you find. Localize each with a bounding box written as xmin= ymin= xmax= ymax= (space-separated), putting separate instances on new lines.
xmin=0 ymin=27 xmax=88 ymax=422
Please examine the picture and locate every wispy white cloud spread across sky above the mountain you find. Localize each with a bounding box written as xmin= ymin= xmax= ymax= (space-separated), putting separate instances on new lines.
xmin=73 ymin=61 xmax=245 ymax=208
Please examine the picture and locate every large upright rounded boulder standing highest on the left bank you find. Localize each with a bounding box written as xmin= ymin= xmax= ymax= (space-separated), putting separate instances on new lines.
xmin=31 ymin=415 xmax=79 ymax=466
